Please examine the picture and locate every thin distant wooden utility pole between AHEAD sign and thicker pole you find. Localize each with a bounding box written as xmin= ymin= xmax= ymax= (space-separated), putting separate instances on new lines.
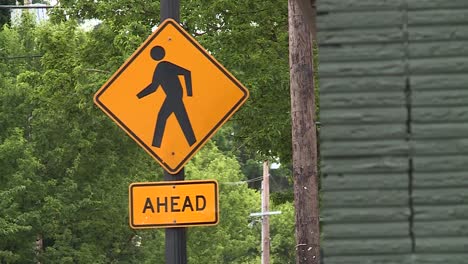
xmin=262 ymin=160 xmax=270 ymax=264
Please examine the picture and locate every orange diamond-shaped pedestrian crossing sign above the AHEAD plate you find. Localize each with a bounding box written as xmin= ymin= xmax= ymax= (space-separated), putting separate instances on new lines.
xmin=94 ymin=19 xmax=249 ymax=174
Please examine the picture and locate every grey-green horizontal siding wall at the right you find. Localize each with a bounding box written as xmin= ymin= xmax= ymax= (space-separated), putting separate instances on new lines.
xmin=317 ymin=0 xmax=468 ymax=264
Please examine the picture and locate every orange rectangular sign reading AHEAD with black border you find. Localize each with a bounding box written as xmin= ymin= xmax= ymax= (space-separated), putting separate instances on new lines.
xmin=129 ymin=180 xmax=219 ymax=229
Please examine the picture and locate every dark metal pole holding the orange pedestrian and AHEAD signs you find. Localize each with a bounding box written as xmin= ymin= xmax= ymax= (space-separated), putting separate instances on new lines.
xmin=160 ymin=0 xmax=187 ymax=264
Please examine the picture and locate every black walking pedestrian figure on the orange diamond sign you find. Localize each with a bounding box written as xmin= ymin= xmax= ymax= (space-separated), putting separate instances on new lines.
xmin=137 ymin=46 xmax=196 ymax=148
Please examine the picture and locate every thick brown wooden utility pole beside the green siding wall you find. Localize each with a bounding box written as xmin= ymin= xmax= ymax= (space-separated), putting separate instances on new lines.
xmin=288 ymin=0 xmax=320 ymax=264
